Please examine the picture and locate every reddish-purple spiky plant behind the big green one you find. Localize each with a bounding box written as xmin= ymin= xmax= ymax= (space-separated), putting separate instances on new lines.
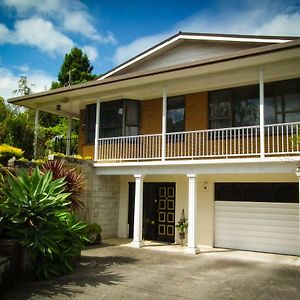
xmin=41 ymin=160 xmax=85 ymax=210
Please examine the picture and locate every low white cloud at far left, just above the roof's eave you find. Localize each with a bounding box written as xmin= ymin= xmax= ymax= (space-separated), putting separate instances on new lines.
xmin=0 ymin=68 xmax=56 ymax=99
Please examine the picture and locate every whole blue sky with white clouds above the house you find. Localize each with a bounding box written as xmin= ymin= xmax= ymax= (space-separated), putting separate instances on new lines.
xmin=0 ymin=0 xmax=300 ymax=99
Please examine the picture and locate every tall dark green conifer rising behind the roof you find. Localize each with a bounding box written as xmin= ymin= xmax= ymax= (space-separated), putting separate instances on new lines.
xmin=51 ymin=47 xmax=96 ymax=89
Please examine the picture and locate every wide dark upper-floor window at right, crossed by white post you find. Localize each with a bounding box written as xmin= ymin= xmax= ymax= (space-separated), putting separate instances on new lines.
xmin=209 ymin=79 xmax=300 ymax=128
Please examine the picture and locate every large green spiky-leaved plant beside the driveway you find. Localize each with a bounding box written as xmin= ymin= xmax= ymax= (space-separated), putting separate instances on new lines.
xmin=0 ymin=168 xmax=88 ymax=278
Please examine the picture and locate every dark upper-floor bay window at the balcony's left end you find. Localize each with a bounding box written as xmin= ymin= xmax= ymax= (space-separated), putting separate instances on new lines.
xmin=86 ymin=99 xmax=140 ymax=144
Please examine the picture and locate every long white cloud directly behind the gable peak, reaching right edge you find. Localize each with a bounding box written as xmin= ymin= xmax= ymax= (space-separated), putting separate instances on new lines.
xmin=114 ymin=1 xmax=300 ymax=64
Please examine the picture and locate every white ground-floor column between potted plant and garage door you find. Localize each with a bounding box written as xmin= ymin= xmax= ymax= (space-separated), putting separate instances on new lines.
xmin=186 ymin=174 xmax=200 ymax=254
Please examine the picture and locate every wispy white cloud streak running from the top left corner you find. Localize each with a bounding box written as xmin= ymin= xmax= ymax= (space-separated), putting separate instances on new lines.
xmin=3 ymin=0 xmax=116 ymax=44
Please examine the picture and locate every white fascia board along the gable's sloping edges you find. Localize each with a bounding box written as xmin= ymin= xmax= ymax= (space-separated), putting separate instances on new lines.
xmin=97 ymin=34 xmax=292 ymax=80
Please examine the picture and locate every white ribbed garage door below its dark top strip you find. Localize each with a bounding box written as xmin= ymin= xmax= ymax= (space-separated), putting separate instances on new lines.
xmin=215 ymin=201 xmax=300 ymax=255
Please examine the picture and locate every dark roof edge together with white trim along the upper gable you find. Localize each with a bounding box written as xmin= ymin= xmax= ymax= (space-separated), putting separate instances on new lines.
xmin=97 ymin=31 xmax=299 ymax=80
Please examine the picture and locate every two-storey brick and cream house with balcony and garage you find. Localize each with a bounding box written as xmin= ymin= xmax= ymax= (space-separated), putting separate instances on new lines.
xmin=10 ymin=32 xmax=300 ymax=255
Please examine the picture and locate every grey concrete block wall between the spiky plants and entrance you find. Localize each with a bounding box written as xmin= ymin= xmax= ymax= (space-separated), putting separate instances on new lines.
xmin=65 ymin=162 xmax=120 ymax=238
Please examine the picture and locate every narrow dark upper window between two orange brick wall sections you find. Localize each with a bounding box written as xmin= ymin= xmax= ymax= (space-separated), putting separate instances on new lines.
xmin=167 ymin=96 xmax=185 ymax=132
